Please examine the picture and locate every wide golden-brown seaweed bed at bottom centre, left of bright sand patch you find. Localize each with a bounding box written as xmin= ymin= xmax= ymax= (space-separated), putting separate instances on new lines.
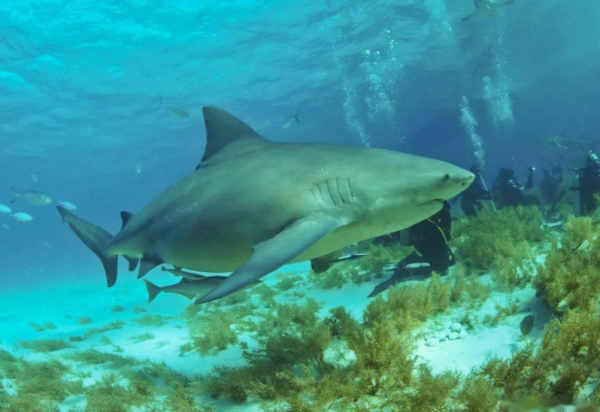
xmin=202 ymin=276 xmax=490 ymax=411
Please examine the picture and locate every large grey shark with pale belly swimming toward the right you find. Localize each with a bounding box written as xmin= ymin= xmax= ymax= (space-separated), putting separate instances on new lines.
xmin=57 ymin=107 xmax=474 ymax=303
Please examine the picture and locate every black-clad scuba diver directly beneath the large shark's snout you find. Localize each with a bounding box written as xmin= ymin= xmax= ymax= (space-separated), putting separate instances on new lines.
xmin=369 ymin=201 xmax=455 ymax=297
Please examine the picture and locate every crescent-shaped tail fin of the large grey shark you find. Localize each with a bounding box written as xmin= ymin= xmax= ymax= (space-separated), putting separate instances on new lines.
xmin=56 ymin=206 xmax=117 ymax=287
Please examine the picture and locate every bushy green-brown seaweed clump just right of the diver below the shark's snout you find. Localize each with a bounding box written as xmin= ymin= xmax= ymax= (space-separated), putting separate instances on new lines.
xmin=453 ymin=206 xmax=546 ymax=271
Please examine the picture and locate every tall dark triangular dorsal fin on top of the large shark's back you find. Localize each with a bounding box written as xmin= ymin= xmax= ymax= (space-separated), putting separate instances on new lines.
xmin=202 ymin=106 xmax=266 ymax=162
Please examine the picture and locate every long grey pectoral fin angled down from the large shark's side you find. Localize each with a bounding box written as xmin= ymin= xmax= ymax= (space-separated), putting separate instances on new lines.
xmin=195 ymin=215 xmax=345 ymax=304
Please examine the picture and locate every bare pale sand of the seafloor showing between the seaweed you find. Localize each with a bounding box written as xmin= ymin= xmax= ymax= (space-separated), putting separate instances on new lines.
xmin=0 ymin=264 xmax=550 ymax=411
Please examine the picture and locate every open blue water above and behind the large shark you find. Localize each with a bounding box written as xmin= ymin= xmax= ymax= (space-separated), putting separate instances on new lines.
xmin=0 ymin=0 xmax=600 ymax=288
